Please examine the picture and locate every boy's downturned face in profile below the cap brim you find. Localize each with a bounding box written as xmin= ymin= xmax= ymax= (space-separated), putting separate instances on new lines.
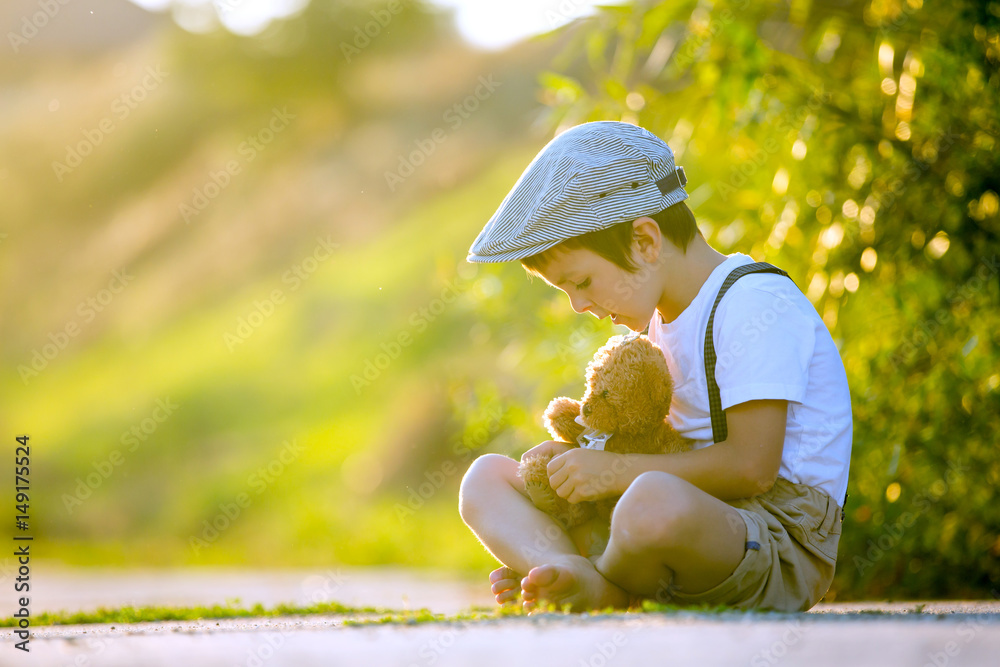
xmin=538 ymin=248 xmax=658 ymax=331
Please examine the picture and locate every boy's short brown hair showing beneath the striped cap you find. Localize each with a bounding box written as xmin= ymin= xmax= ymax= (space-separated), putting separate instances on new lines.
xmin=521 ymin=201 xmax=704 ymax=278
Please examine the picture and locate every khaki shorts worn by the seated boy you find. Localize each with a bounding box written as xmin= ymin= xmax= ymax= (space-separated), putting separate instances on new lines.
xmin=664 ymin=477 xmax=841 ymax=611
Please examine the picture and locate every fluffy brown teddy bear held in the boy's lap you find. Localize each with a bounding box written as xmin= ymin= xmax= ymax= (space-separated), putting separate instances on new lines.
xmin=517 ymin=334 xmax=694 ymax=548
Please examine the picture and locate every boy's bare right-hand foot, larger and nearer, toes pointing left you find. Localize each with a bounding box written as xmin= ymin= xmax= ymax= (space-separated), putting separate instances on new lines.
xmin=521 ymin=555 xmax=629 ymax=613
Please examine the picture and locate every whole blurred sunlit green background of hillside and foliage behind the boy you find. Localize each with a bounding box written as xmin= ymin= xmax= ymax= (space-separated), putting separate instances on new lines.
xmin=0 ymin=0 xmax=1000 ymax=601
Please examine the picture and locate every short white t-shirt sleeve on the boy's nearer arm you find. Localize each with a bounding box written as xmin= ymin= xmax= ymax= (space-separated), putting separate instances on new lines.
xmin=714 ymin=279 xmax=816 ymax=410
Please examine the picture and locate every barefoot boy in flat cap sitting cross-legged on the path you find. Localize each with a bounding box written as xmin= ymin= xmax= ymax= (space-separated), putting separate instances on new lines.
xmin=459 ymin=121 xmax=852 ymax=611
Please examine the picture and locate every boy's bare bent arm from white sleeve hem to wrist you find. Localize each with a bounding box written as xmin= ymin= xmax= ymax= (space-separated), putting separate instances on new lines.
xmin=618 ymin=400 xmax=788 ymax=500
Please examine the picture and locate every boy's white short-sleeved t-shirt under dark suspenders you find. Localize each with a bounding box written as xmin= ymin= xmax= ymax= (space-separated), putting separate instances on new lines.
xmin=648 ymin=253 xmax=853 ymax=507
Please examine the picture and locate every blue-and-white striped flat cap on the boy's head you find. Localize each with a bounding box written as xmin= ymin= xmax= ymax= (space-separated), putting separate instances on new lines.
xmin=466 ymin=120 xmax=688 ymax=262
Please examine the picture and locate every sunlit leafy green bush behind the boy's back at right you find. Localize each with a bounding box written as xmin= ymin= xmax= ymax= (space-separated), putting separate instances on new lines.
xmin=524 ymin=0 xmax=1000 ymax=600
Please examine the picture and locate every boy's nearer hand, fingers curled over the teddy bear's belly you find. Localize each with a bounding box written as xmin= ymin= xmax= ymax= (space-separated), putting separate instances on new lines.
xmin=546 ymin=447 xmax=629 ymax=503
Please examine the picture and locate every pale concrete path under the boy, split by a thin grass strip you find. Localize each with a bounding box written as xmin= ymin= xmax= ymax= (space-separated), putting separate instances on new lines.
xmin=0 ymin=568 xmax=1000 ymax=667
